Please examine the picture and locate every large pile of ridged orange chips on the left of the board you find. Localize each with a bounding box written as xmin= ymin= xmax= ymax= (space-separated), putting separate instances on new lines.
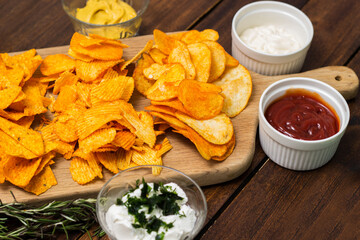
xmin=0 ymin=33 xmax=172 ymax=195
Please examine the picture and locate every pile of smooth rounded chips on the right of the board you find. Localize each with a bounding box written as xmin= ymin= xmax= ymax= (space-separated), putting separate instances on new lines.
xmin=133 ymin=29 xmax=252 ymax=161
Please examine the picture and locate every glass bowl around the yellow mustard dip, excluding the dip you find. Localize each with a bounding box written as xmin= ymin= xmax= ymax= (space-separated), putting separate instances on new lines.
xmin=61 ymin=0 xmax=150 ymax=39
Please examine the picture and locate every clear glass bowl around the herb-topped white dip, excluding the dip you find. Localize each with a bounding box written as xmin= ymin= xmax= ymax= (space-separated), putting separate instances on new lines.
xmin=96 ymin=165 xmax=207 ymax=239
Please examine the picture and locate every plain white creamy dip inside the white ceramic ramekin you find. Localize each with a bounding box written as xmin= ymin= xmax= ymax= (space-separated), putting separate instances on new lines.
xmin=239 ymin=24 xmax=302 ymax=55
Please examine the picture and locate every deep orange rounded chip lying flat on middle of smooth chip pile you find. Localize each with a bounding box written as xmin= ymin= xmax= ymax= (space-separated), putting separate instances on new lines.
xmin=178 ymin=80 xmax=224 ymax=119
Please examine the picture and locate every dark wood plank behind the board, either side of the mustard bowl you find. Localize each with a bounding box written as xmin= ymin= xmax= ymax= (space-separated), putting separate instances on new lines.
xmin=0 ymin=0 xmax=219 ymax=52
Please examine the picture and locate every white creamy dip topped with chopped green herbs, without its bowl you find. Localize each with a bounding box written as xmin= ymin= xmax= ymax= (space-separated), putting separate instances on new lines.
xmin=105 ymin=182 xmax=196 ymax=240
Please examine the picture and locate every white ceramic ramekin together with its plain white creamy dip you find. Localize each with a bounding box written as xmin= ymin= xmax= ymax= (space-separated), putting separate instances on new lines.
xmin=231 ymin=1 xmax=314 ymax=75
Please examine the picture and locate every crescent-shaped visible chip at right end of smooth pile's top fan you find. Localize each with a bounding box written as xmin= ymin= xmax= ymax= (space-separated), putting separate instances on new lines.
xmin=203 ymin=41 xmax=226 ymax=82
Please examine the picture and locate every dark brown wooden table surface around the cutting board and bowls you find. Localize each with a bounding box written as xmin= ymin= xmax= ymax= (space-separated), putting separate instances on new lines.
xmin=0 ymin=0 xmax=360 ymax=240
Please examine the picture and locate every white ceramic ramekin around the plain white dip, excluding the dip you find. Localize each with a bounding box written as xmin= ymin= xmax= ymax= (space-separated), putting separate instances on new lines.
xmin=231 ymin=1 xmax=314 ymax=75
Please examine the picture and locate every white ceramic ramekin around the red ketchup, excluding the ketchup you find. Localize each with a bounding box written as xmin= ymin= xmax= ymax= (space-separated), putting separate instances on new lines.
xmin=259 ymin=77 xmax=350 ymax=170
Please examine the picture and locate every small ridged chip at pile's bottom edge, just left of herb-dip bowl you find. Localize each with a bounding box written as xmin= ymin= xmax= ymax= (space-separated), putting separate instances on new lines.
xmin=70 ymin=157 xmax=97 ymax=185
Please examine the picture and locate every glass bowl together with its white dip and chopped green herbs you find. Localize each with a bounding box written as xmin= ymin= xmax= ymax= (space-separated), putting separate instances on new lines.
xmin=96 ymin=165 xmax=207 ymax=240
